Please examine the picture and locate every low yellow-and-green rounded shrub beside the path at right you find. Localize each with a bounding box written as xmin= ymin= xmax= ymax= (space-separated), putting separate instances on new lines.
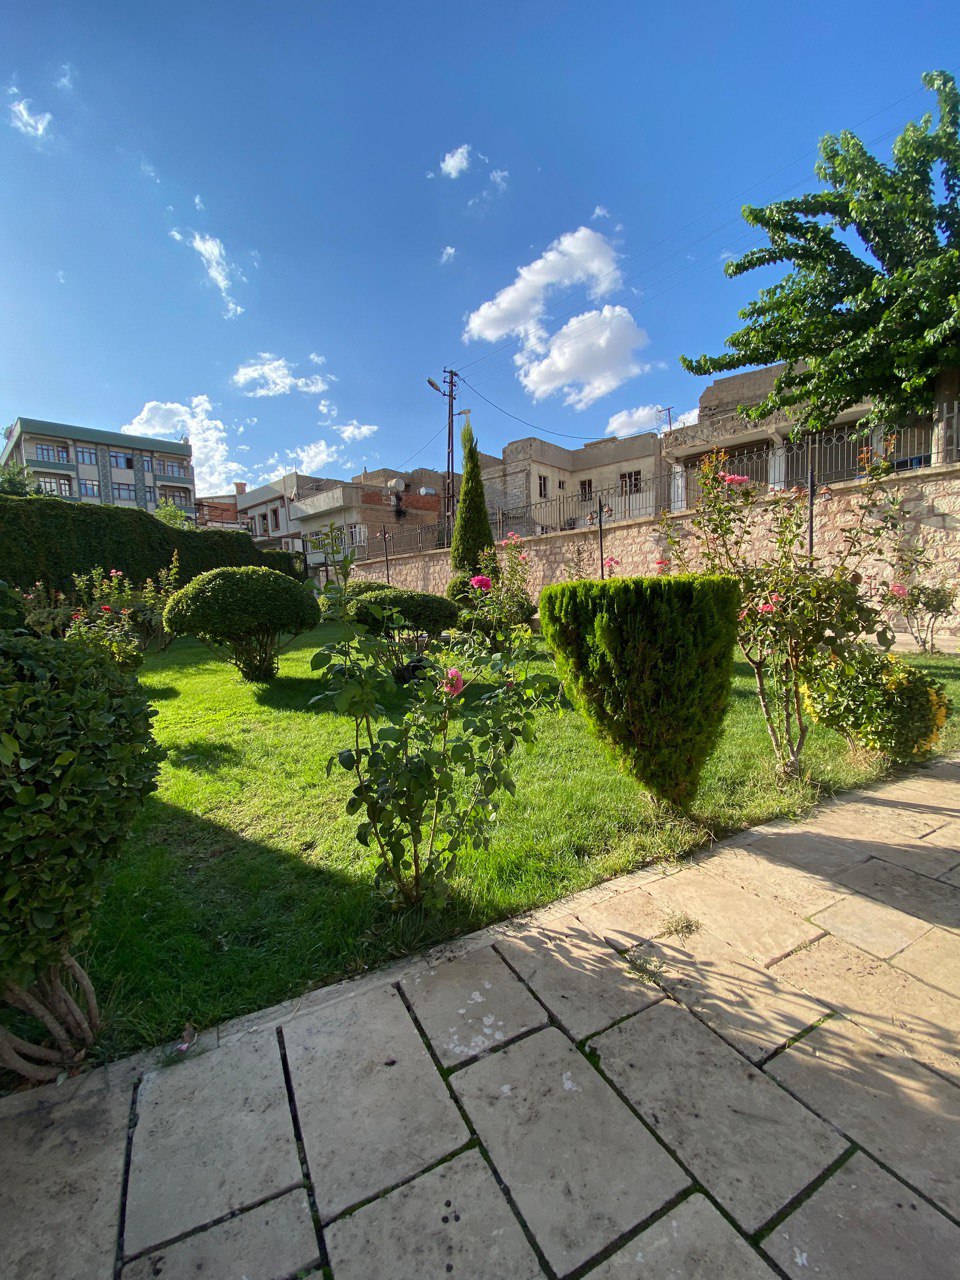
xmin=804 ymin=645 xmax=951 ymax=762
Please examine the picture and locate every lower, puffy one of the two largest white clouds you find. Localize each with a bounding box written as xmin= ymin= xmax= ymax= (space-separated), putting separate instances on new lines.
xmin=515 ymin=306 xmax=650 ymax=410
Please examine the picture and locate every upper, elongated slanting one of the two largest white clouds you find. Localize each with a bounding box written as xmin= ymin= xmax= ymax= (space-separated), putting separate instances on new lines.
xmin=463 ymin=227 xmax=621 ymax=351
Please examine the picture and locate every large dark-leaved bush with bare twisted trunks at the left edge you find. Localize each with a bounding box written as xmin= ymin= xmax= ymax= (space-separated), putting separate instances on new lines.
xmin=0 ymin=635 xmax=161 ymax=1080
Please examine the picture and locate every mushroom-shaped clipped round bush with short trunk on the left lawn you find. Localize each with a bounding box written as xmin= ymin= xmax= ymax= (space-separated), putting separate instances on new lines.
xmin=164 ymin=566 xmax=320 ymax=681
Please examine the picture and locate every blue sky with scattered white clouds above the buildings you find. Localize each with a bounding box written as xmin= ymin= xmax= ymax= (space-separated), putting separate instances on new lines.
xmin=0 ymin=0 xmax=960 ymax=492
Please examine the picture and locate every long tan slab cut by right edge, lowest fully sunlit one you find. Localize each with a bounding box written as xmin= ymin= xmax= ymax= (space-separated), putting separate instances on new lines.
xmin=776 ymin=936 xmax=960 ymax=1083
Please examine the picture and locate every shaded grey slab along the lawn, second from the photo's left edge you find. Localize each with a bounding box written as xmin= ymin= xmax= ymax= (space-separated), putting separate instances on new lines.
xmin=124 ymin=1033 xmax=302 ymax=1257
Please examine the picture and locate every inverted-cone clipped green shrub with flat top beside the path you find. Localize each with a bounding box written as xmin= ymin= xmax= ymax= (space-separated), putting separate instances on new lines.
xmin=540 ymin=575 xmax=740 ymax=805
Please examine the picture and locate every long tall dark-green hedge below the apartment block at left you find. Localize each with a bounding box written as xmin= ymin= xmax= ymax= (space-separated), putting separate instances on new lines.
xmin=0 ymin=497 xmax=300 ymax=591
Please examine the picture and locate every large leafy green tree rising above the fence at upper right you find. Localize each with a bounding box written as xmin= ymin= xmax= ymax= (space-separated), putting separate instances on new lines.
xmin=681 ymin=72 xmax=960 ymax=430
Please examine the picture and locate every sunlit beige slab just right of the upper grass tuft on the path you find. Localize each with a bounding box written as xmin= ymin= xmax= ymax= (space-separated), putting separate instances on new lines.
xmin=640 ymin=867 xmax=823 ymax=965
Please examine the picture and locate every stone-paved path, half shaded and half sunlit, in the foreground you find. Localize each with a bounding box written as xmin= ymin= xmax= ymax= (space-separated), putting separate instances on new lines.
xmin=0 ymin=762 xmax=960 ymax=1280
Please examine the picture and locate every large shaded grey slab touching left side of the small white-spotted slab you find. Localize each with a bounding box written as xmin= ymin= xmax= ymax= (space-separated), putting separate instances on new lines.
xmin=284 ymin=987 xmax=470 ymax=1221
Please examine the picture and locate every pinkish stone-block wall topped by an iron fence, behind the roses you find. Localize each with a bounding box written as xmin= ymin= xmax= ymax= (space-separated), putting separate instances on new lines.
xmin=353 ymin=463 xmax=960 ymax=635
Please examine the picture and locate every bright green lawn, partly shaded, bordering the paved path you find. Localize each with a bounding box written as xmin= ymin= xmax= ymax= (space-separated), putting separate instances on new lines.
xmin=67 ymin=637 xmax=960 ymax=1057
